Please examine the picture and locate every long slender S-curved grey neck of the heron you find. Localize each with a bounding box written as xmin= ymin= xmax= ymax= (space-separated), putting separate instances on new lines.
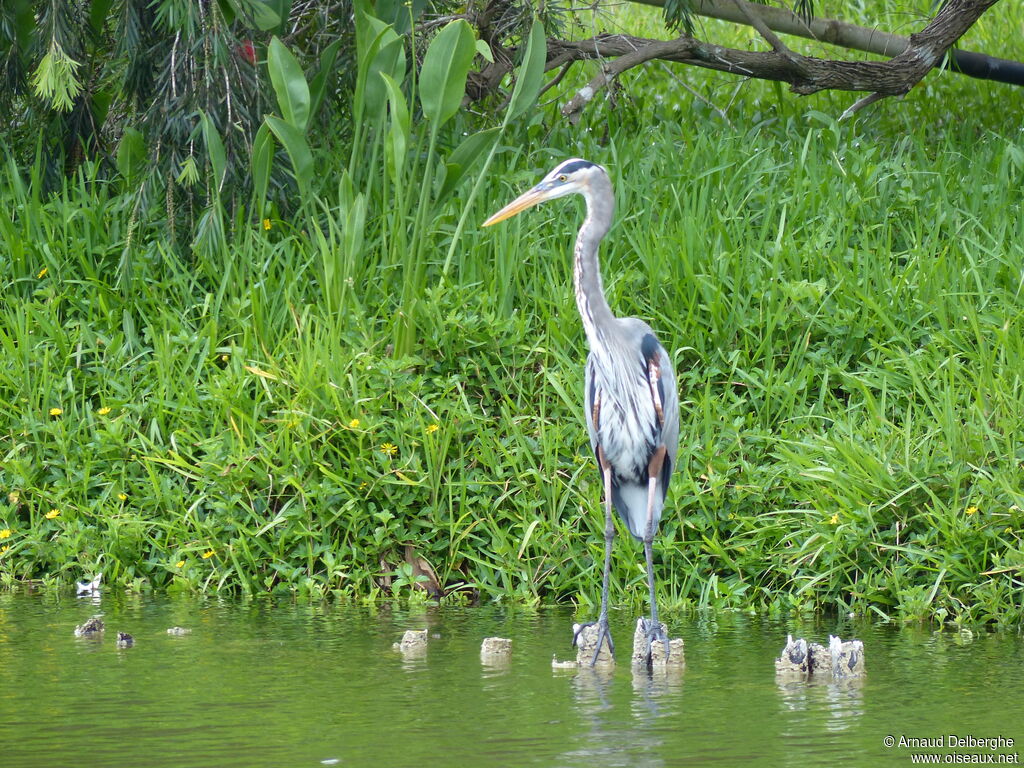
xmin=573 ymin=178 xmax=615 ymax=349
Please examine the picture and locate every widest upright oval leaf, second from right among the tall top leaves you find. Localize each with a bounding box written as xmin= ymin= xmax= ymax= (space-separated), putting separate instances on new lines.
xmin=420 ymin=18 xmax=476 ymax=129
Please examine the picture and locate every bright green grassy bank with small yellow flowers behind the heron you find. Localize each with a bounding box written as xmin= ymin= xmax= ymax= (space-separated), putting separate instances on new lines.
xmin=0 ymin=0 xmax=1024 ymax=626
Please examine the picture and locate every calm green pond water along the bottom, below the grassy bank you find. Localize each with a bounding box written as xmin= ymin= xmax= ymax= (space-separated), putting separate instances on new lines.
xmin=0 ymin=593 xmax=1024 ymax=768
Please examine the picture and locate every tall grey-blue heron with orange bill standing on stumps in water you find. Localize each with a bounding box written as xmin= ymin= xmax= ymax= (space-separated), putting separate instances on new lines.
xmin=483 ymin=158 xmax=679 ymax=665
